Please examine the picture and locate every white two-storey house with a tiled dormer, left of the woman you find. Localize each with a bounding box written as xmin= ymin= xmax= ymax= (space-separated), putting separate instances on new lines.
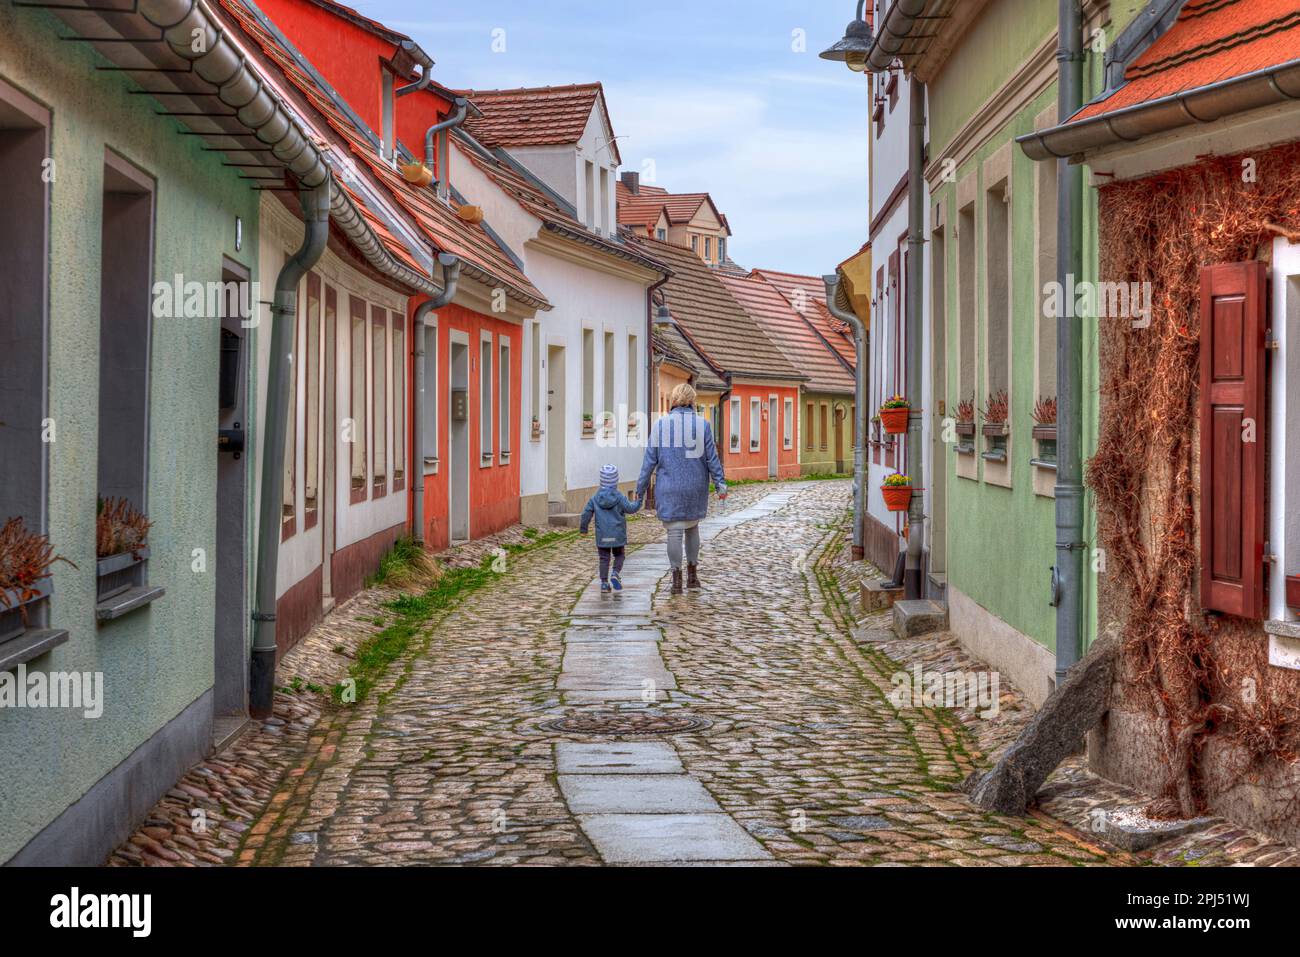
xmin=451 ymin=85 xmax=666 ymax=523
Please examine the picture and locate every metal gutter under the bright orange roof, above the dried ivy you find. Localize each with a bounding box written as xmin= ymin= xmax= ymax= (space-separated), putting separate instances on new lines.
xmin=1015 ymin=59 xmax=1300 ymax=160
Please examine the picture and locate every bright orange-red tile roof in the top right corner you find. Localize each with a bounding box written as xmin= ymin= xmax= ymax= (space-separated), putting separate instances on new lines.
xmin=1073 ymin=0 xmax=1300 ymax=121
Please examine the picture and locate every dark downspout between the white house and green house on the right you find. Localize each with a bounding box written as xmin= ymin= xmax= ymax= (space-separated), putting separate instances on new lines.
xmin=904 ymin=75 xmax=927 ymax=599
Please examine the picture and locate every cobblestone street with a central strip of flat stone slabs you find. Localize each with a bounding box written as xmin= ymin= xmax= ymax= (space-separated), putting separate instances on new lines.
xmin=113 ymin=481 xmax=1292 ymax=866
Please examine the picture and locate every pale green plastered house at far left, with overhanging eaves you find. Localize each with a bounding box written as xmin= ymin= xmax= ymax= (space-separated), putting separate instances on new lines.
xmin=0 ymin=0 xmax=437 ymax=865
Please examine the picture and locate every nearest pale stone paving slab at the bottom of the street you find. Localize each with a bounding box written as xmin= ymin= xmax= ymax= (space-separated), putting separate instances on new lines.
xmin=579 ymin=814 xmax=771 ymax=863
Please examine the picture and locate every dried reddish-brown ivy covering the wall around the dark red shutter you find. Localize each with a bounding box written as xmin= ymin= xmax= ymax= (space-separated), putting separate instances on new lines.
xmin=1088 ymin=146 xmax=1300 ymax=817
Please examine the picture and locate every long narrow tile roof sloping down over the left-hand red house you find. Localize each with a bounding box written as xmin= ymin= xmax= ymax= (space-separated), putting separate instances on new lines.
xmin=217 ymin=0 xmax=550 ymax=308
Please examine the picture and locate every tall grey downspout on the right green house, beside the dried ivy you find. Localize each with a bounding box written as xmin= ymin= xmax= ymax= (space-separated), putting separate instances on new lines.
xmin=1053 ymin=0 xmax=1087 ymax=687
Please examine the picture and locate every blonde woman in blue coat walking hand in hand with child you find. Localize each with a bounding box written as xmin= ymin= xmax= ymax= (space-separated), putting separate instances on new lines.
xmin=636 ymin=382 xmax=727 ymax=594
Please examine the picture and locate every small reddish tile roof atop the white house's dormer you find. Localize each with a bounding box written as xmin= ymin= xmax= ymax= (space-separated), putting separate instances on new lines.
xmin=462 ymin=83 xmax=620 ymax=164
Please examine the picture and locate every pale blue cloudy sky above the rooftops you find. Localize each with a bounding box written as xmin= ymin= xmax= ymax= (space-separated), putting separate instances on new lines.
xmin=351 ymin=0 xmax=870 ymax=274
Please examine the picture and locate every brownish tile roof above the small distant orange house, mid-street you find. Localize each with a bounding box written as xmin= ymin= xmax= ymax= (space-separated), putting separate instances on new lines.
xmin=628 ymin=237 xmax=803 ymax=380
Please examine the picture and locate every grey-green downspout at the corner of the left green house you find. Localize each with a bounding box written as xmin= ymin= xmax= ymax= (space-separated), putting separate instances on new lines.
xmin=248 ymin=176 xmax=332 ymax=719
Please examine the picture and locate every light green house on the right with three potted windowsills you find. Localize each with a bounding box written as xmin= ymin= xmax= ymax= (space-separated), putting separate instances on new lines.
xmin=874 ymin=0 xmax=1169 ymax=705
